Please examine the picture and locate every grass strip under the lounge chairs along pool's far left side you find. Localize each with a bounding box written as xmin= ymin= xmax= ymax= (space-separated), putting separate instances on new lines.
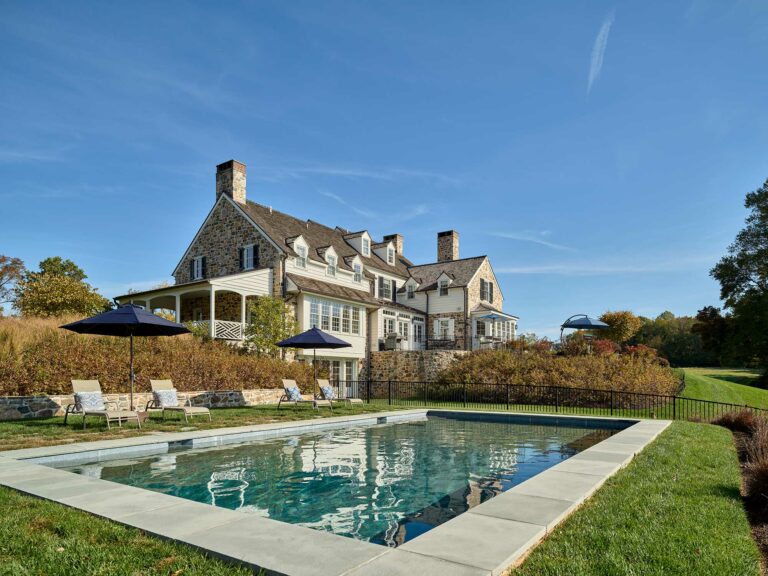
xmin=0 ymin=404 xmax=398 ymax=450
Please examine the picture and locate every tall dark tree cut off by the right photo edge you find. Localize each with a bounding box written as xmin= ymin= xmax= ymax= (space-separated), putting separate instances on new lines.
xmin=710 ymin=180 xmax=768 ymax=381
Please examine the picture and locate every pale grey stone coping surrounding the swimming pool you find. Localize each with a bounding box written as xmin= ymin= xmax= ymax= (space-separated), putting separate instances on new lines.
xmin=0 ymin=408 xmax=671 ymax=576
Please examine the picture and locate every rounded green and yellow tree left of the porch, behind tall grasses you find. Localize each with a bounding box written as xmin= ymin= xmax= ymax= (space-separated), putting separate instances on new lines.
xmin=14 ymin=256 xmax=112 ymax=316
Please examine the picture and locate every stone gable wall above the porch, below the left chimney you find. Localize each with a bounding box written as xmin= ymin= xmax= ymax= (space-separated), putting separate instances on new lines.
xmin=173 ymin=201 xmax=282 ymax=290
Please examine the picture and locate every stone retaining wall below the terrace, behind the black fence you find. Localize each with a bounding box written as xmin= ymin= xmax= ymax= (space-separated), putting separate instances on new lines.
xmin=370 ymin=350 xmax=467 ymax=382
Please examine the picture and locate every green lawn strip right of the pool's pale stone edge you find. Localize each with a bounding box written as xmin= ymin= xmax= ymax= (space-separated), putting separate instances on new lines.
xmin=511 ymin=422 xmax=760 ymax=576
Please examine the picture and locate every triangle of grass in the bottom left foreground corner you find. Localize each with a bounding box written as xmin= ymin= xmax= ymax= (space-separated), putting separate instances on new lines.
xmin=0 ymin=488 xmax=252 ymax=576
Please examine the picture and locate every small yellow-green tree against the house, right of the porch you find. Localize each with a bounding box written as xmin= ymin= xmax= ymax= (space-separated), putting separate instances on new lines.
xmin=245 ymin=296 xmax=298 ymax=357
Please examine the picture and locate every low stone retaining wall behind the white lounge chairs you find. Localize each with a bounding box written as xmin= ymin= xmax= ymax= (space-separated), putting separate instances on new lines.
xmin=0 ymin=388 xmax=283 ymax=420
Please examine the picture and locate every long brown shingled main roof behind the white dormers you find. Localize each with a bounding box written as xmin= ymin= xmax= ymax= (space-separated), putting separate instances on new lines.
xmin=240 ymin=200 xmax=412 ymax=278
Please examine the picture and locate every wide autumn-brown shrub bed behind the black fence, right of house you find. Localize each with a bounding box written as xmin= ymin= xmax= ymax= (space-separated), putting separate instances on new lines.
xmin=439 ymin=350 xmax=679 ymax=395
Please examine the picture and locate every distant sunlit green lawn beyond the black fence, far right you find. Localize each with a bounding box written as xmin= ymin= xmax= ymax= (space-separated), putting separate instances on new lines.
xmin=682 ymin=368 xmax=768 ymax=408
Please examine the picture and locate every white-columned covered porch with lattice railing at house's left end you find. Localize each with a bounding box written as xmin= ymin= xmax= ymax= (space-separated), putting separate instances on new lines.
xmin=116 ymin=269 xmax=272 ymax=342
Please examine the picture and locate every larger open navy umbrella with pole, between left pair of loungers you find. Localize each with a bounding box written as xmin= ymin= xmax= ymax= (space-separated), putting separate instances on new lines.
xmin=62 ymin=304 xmax=189 ymax=410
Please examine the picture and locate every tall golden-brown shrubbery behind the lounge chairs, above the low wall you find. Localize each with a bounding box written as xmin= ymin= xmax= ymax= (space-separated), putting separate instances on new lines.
xmin=0 ymin=318 xmax=312 ymax=396
